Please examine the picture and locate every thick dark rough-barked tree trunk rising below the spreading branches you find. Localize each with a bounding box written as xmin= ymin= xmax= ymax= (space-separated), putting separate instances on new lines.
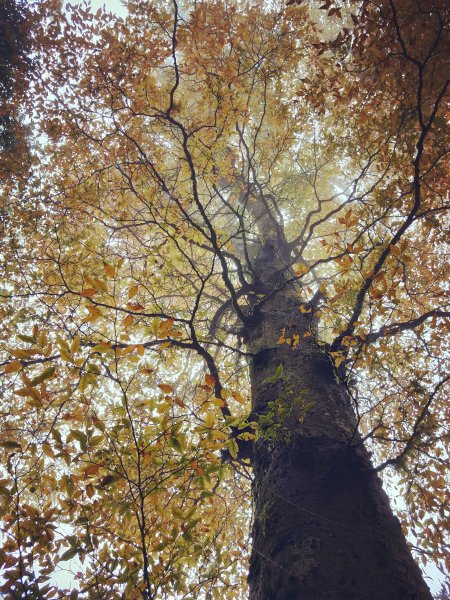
xmin=248 ymin=280 xmax=431 ymax=600
